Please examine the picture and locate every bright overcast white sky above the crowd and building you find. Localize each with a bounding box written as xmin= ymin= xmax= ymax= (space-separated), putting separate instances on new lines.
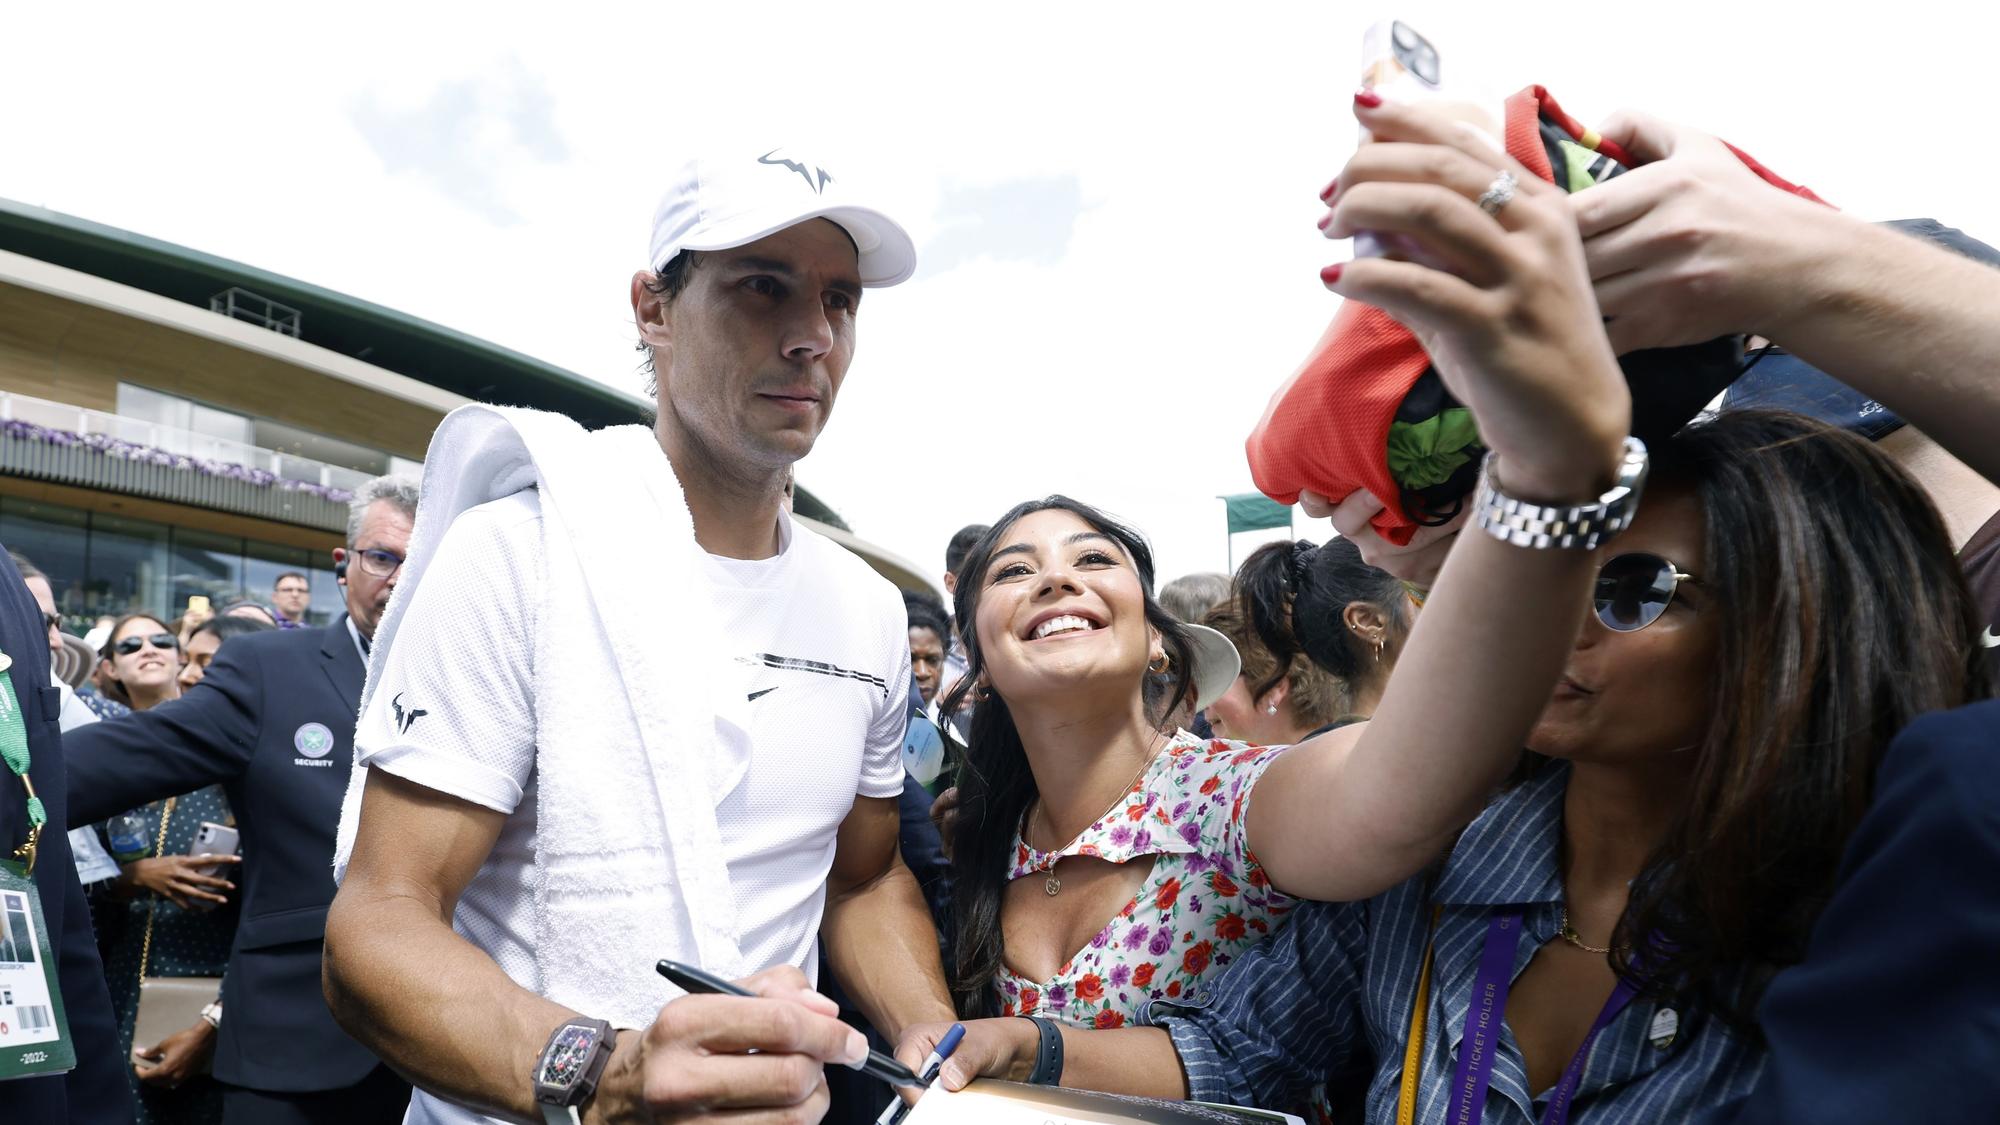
xmin=0 ymin=0 xmax=2000 ymax=579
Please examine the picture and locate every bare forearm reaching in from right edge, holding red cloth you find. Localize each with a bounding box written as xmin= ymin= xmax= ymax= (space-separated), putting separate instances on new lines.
xmin=1758 ymin=208 xmax=2000 ymax=482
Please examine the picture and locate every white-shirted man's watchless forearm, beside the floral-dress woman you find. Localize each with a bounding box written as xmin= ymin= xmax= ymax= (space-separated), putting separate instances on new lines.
xmin=820 ymin=859 xmax=952 ymax=1043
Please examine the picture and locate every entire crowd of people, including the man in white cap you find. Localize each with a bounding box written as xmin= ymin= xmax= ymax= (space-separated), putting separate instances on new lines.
xmin=0 ymin=92 xmax=2000 ymax=1125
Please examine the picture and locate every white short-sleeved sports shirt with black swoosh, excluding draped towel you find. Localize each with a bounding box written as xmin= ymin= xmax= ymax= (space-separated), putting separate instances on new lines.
xmin=354 ymin=490 xmax=910 ymax=1125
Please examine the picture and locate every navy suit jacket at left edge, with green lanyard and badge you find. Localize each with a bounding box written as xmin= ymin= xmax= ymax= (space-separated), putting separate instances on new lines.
xmin=0 ymin=550 xmax=132 ymax=1123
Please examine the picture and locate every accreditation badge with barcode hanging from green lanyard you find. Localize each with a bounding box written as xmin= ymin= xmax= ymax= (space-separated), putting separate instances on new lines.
xmin=0 ymin=863 xmax=76 ymax=1081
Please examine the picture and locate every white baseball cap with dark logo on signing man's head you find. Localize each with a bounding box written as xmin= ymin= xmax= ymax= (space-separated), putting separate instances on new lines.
xmin=646 ymin=148 xmax=916 ymax=286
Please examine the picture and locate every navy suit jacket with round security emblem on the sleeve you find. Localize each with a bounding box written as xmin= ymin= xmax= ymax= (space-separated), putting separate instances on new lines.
xmin=68 ymin=619 xmax=378 ymax=1091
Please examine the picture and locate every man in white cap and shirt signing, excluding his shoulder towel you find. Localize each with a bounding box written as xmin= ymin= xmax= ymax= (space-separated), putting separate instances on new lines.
xmin=324 ymin=152 xmax=950 ymax=1125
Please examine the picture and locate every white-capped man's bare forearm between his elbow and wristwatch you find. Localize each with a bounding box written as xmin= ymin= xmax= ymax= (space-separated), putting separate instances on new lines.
xmin=322 ymin=885 xmax=576 ymax=1123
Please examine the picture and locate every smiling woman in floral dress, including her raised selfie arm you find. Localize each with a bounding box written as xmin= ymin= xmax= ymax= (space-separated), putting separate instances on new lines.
xmin=904 ymin=94 xmax=1644 ymax=1051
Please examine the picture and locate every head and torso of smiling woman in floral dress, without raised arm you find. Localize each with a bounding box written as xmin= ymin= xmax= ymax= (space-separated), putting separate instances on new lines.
xmin=928 ymin=496 xmax=1292 ymax=1027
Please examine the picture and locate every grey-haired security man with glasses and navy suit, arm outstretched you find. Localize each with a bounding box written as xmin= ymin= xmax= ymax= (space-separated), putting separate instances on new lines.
xmin=64 ymin=476 xmax=418 ymax=1123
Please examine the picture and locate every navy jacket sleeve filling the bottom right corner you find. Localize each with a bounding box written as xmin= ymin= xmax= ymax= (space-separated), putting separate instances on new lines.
xmin=1710 ymin=701 xmax=2000 ymax=1125
